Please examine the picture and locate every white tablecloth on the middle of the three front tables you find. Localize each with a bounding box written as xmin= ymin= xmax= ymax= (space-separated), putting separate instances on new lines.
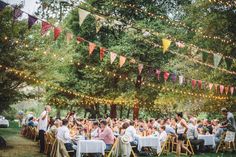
xmin=135 ymin=136 xmax=161 ymax=153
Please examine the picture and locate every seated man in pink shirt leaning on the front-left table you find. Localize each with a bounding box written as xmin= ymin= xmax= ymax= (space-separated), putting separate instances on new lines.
xmin=95 ymin=120 xmax=115 ymax=150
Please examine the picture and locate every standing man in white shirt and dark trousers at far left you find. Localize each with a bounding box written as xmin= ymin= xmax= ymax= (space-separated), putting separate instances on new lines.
xmin=38 ymin=105 xmax=51 ymax=153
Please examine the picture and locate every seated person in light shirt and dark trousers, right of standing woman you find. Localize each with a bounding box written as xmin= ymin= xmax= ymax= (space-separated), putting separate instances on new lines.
xmin=187 ymin=118 xmax=204 ymax=153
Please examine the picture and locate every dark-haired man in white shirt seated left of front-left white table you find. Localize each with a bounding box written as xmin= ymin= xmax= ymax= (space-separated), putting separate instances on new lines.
xmin=57 ymin=119 xmax=73 ymax=150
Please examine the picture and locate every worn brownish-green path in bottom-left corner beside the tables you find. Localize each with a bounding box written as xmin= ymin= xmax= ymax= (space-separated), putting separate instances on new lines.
xmin=0 ymin=128 xmax=46 ymax=157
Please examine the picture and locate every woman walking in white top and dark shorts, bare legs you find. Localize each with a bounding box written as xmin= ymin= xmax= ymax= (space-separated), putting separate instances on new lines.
xmin=176 ymin=112 xmax=192 ymax=156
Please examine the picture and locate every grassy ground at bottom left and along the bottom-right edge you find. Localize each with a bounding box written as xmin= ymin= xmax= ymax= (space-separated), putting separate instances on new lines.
xmin=0 ymin=123 xmax=236 ymax=157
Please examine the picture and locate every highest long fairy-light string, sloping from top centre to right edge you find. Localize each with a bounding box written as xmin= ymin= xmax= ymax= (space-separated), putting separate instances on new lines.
xmin=108 ymin=1 xmax=236 ymax=46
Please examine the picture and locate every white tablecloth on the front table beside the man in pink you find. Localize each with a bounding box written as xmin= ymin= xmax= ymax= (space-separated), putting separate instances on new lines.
xmin=76 ymin=140 xmax=106 ymax=157
